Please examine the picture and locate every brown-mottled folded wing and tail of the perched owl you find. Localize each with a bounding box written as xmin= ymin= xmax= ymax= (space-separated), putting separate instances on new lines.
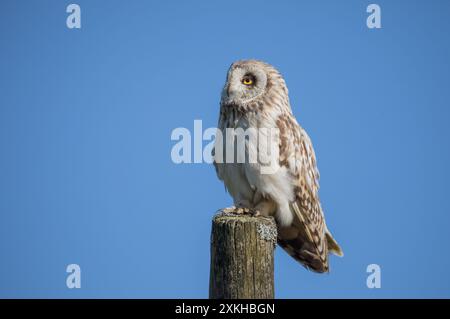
xmin=278 ymin=117 xmax=342 ymax=272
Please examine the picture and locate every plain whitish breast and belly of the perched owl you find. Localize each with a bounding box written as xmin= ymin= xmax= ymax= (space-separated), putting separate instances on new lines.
xmin=216 ymin=107 xmax=294 ymax=214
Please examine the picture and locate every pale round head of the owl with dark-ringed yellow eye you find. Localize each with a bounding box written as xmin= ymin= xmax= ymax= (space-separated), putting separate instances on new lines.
xmin=222 ymin=60 xmax=287 ymax=108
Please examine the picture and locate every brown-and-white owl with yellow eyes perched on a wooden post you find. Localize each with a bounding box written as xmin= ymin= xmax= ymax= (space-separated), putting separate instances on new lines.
xmin=213 ymin=60 xmax=343 ymax=273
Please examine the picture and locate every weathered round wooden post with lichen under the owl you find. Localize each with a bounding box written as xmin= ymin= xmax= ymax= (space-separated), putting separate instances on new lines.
xmin=209 ymin=212 xmax=277 ymax=299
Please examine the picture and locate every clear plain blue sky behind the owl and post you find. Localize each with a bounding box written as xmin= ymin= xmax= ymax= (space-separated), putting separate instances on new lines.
xmin=0 ymin=0 xmax=450 ymax=298
